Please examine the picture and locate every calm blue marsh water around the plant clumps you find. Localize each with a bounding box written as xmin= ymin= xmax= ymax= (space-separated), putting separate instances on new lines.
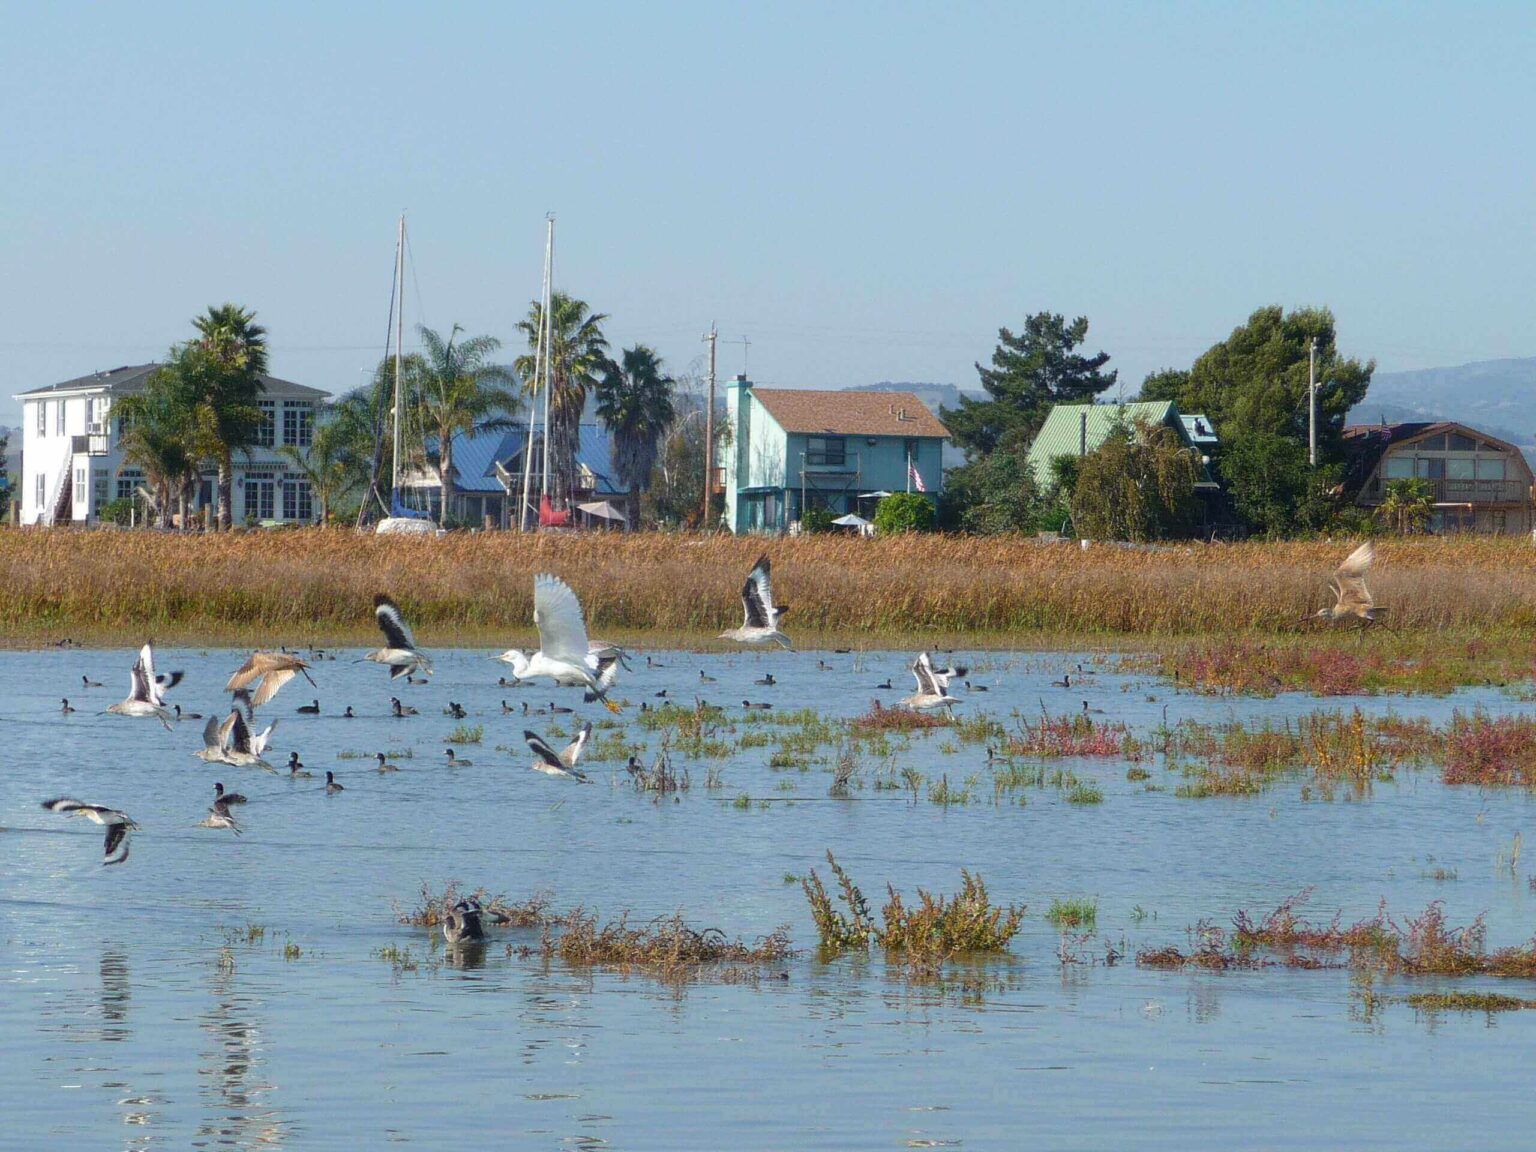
xmin=0 ymin=637 xmax=1536 ymax=1149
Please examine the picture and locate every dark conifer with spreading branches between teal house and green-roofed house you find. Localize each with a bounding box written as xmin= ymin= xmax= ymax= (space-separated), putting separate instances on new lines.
xmin=938 ymin=312 xmax=1118 ymax=459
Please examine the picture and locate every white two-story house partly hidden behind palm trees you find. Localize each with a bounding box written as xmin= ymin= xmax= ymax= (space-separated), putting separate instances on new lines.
xmin=12 ymin=364 xmax=329 ymax=524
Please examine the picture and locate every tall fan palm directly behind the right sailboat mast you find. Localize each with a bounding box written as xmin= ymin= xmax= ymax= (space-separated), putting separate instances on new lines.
xmin=516 ymin=292 xmax=608 ymax=504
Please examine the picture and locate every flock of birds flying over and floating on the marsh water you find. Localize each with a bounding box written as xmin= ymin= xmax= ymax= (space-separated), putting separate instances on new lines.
xmin=43 ymin=542 xmax=1382 ymax=943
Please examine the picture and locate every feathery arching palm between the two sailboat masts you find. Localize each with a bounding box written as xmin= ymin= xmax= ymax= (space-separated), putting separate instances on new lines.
xmin=416 ymin=324 xmax=518 ymax=525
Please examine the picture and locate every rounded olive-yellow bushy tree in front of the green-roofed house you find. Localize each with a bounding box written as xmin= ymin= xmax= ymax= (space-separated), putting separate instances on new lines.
xmin=1072 ymin=422 xmax=1200 ymax=541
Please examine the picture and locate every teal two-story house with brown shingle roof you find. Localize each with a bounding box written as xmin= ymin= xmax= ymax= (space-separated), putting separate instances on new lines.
xmin=719 ymin=384 xmax=949 ymax=533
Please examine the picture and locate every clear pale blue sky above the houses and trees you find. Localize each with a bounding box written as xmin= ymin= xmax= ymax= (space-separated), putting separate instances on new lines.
xmin=0 ymin=3 xmax=1536 ymax=422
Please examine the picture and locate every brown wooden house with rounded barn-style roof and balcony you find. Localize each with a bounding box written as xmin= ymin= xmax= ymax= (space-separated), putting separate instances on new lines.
xmin=1344 ymin=421 xmax=1536 ymax=535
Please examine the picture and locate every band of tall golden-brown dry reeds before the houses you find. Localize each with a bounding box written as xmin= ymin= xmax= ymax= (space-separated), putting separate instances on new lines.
xmin=0 ymin=528 xmax=1536 ymax=644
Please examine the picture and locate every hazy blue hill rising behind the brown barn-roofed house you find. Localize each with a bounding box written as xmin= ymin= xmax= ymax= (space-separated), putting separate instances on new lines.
xmin=1349 ymin=356 xmax=1536 ymax=456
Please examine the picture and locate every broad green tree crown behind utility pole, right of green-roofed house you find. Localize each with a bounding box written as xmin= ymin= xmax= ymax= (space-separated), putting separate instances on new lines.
xmin=1141 ymin=304 xmax=1376 ymax=462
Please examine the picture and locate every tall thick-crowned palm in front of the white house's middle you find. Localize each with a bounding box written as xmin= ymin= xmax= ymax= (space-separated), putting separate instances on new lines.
xmin=187 ymin=304 xmax=267 ymax=530
